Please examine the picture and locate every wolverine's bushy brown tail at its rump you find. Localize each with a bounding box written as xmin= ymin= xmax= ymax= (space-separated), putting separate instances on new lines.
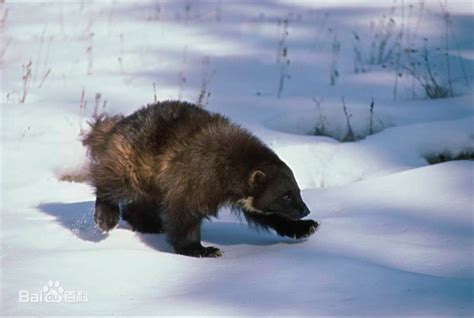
xmin=82 ymin=114 xmax=123 ymax=158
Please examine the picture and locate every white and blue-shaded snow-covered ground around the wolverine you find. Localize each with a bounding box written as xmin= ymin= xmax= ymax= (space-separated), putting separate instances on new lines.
xmin=0 ymin=0 xmax=474 ymax=316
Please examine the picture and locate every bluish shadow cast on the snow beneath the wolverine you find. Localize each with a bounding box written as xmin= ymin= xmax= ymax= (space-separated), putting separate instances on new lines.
xmin=38 ymin=201 xmax=294 ymax=252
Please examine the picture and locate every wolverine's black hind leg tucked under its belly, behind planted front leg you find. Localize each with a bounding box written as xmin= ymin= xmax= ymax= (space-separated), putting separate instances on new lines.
xmin=122 ymin=201 xmax=163 ymax=233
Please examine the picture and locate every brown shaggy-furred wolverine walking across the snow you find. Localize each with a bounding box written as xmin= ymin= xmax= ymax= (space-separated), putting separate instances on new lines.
xmin=83 ymin=101 xmax=318 ymax=257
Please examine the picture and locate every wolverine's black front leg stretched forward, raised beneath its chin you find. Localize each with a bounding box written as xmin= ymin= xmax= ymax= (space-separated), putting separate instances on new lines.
xmin=244 ymin=211 xmax=319 ymax=239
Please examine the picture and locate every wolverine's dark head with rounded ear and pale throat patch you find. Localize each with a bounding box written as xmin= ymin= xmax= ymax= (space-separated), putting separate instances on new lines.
xmin=239 ymin=162 xmax=310 ymax=220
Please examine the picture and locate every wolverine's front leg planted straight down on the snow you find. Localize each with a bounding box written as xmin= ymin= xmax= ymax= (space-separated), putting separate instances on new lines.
xmin=163 ymin=213 xmax=222 ymax=257
